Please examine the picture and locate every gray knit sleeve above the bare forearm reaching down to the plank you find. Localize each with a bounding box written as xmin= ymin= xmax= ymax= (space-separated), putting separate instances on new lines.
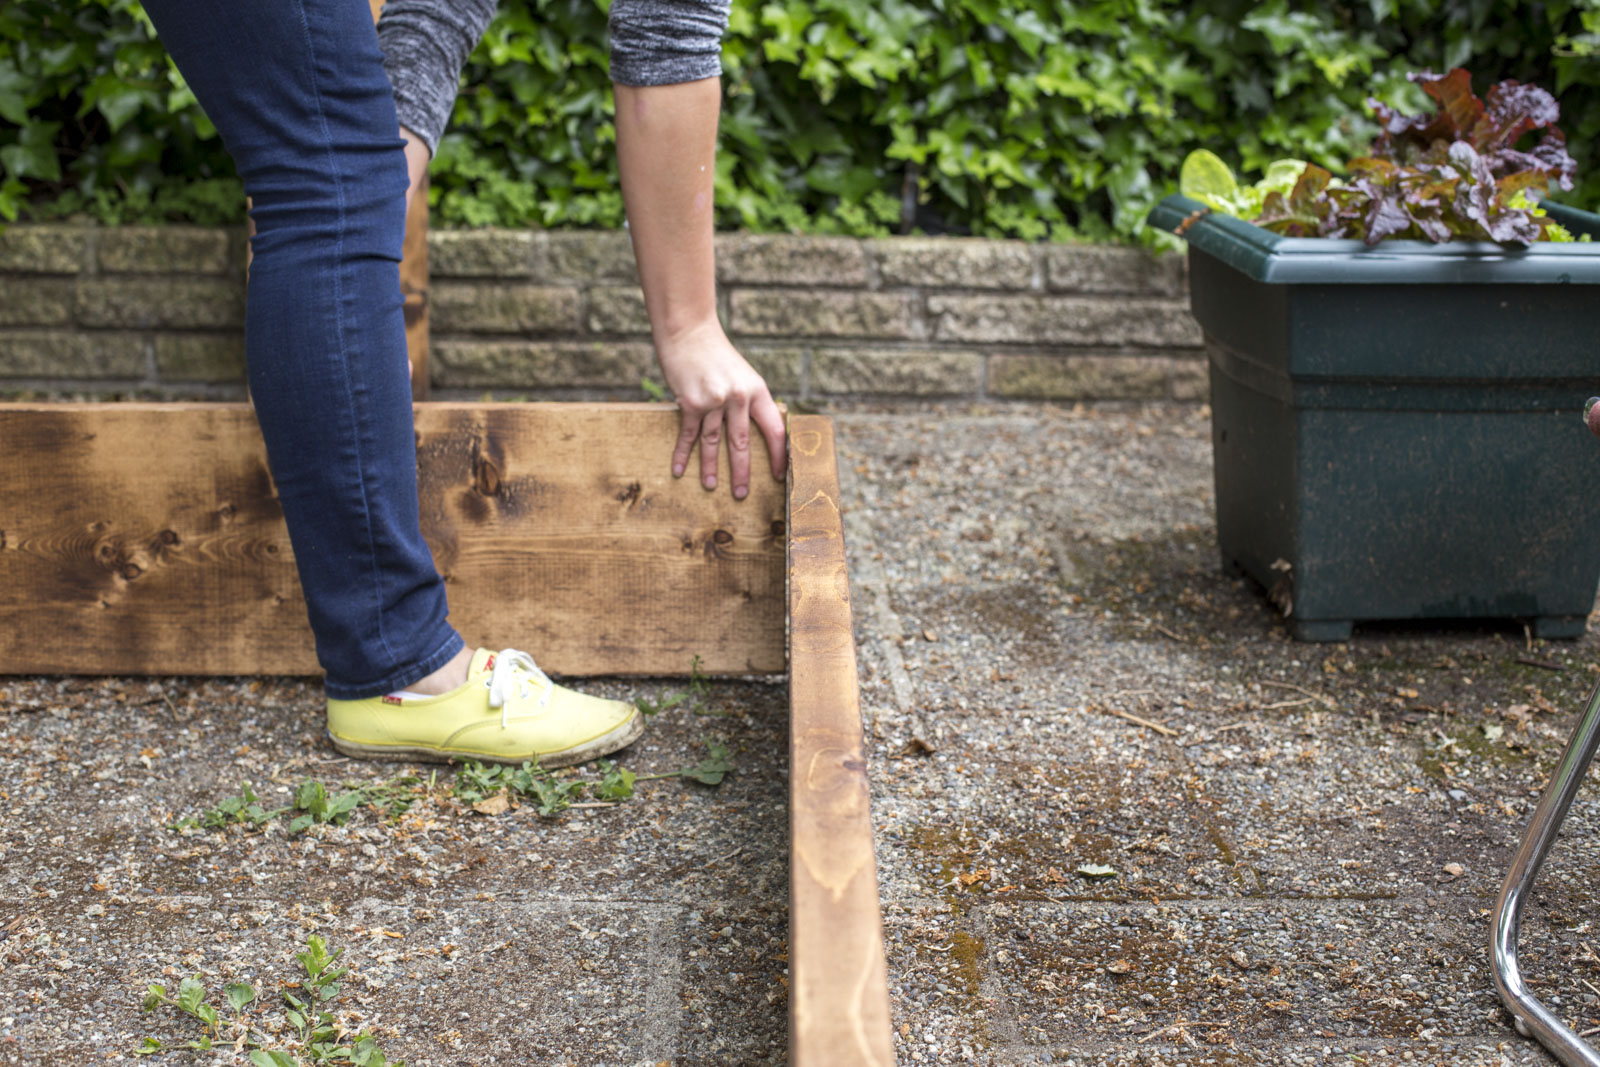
xmin=611 ymin=0 xmax=731 ymax=85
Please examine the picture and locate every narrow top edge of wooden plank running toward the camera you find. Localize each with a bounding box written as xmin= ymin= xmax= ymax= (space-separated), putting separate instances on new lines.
xmin=789 ymin=416 xmax=894 ymax=1067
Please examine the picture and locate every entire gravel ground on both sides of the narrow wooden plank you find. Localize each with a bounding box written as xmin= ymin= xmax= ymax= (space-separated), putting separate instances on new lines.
xmin=0 ymin=406 xmax=1600 ymax=1067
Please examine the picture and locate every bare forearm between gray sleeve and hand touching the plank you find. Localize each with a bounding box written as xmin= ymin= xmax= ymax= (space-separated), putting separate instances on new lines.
xmin=616 ymin=78 xmax=722 ymax=350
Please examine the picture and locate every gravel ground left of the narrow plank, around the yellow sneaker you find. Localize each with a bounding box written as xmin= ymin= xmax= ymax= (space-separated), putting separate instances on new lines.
xmin=0 ymin=678 xmax=789 ymax=1065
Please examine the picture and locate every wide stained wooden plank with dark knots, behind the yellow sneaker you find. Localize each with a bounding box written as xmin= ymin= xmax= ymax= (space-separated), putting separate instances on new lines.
xmin=0 ymin=403 xmax=784 ymax=675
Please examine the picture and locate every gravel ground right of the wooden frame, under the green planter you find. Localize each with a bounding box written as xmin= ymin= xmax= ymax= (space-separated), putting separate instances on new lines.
xmin=840 ymin=406 xmax=1600 ymax=1067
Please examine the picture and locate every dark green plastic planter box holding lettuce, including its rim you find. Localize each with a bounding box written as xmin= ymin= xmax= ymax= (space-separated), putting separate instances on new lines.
xmin=1150 ymin=197 xmax=1600 ymax=641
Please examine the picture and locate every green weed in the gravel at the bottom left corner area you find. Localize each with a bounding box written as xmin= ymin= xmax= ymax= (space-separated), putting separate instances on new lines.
xmin=134 ymin=934 xmax=405 ymax=1067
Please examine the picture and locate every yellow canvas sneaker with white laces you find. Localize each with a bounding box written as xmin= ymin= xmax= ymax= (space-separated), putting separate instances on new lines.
xmin=328 ymin=648 xmax=645 ymax=766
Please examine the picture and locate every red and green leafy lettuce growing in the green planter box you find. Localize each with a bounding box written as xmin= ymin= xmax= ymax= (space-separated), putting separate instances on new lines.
xmin=1184 ymin=67 xmax=1576 ymax=245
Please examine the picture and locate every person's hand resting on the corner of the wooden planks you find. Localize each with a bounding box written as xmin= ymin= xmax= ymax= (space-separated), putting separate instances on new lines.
xmin=656 ymin=318 xmax=789 ymax=501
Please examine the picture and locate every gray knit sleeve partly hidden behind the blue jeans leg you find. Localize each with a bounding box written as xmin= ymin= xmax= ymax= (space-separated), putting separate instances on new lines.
xmin=378 ymin=0 xmax=494 ymax=154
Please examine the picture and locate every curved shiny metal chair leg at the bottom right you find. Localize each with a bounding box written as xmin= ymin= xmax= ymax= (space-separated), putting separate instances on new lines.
xmin=1490 ymin=685 xmax=1600 ymax=1067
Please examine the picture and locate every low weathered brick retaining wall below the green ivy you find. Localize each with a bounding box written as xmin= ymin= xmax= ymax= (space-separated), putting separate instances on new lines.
xmin=0 ymin=226 xmax=1205 ymax=400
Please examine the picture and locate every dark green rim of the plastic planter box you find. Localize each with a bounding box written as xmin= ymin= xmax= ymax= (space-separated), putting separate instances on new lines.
xmin=1149 ymin=194 xmax=1600 ymax=285
